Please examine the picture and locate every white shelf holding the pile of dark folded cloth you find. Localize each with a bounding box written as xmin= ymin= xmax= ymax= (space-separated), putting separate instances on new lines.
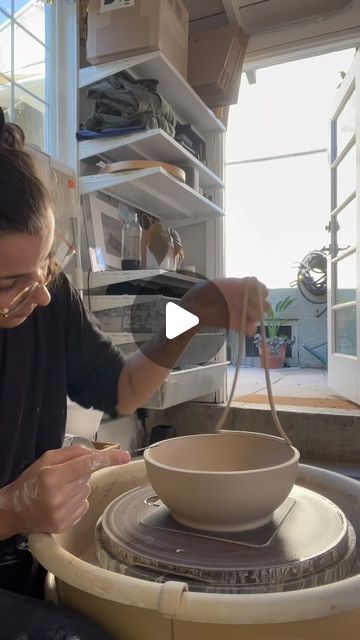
xmin=79 ymin=129 xmax=225 ymax=189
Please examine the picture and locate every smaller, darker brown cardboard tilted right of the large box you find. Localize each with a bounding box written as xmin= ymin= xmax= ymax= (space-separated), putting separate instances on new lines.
xmin=188 ymin=25 xmax=248 ymax=108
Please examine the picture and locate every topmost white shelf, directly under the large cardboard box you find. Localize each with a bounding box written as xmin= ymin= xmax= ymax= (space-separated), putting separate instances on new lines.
xmin=79 ymin=51 xmax=225 ymax=134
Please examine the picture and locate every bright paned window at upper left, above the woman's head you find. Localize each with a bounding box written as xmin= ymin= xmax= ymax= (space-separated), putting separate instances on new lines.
xmin=0 ymin=0 xmax=50 ymax=152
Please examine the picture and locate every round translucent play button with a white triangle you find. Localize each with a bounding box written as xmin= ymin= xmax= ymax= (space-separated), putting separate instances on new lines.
xmin=104 ymin=270 xmax=229 ymax=371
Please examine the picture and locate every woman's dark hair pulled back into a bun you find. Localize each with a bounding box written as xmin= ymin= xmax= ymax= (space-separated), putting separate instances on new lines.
xmin=0 ymin=107 xmax=51 ymax=235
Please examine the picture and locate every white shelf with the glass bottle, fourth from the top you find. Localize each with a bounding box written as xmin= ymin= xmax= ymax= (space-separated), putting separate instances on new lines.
xmin=84 ymin=269 xmax=200 ymax=289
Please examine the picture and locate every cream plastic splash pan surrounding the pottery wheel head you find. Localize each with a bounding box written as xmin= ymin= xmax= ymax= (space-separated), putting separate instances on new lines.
xmin=30 ymin=460 xmax=360 ymax=640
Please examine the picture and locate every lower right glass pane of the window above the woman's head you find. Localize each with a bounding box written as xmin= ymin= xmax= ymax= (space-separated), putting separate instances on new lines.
xmin=14 ymin=87 xmax=46 ymax=149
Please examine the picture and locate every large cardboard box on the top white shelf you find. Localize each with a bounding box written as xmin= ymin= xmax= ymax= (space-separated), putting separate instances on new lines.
xmin=87 ymin=0 xmax=189 ymax=78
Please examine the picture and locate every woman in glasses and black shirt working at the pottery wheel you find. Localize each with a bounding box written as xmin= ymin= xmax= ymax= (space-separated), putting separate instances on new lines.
xmin=0 ymin=114 xmax=268 ymax=638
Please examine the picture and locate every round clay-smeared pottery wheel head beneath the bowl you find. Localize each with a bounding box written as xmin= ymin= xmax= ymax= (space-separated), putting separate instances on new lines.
xmin=96 ymin=485 xmax=356 ymax=593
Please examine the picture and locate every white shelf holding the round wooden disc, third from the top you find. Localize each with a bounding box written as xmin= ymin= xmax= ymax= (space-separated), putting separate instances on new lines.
xmin=79 ymin=167 xmax=224 ymax=220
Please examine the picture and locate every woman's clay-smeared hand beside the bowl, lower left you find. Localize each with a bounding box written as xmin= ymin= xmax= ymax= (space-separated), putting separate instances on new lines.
xmin=0 ymin=446 xmax=130 ymax=536
